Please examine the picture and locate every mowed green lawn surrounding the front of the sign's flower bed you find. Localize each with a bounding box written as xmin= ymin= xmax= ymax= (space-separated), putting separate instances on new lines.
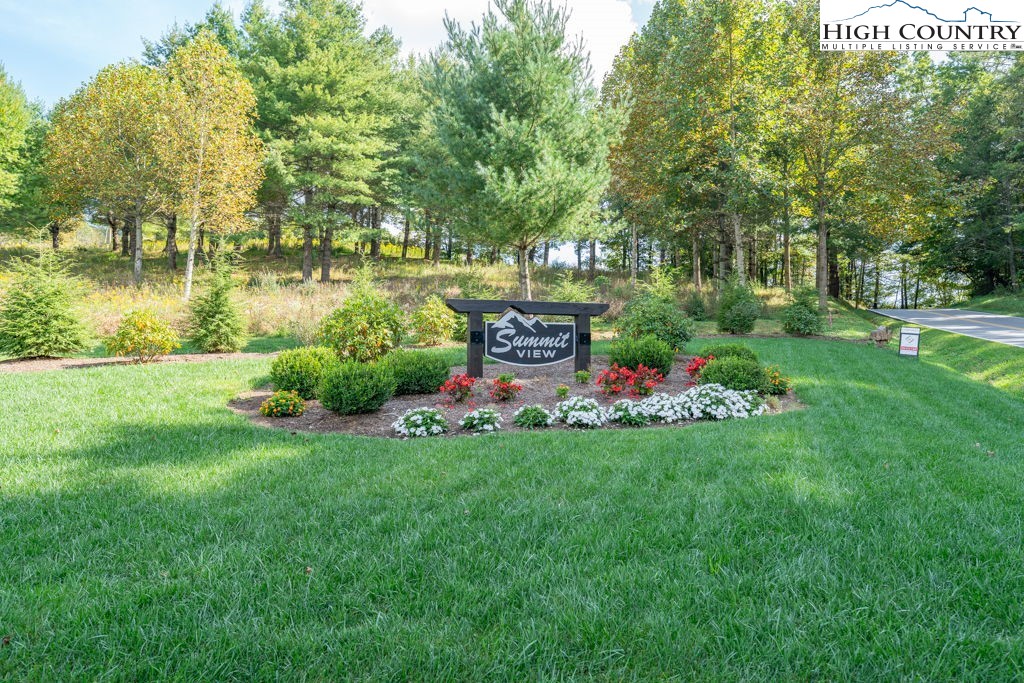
xmin=0 ymin=339 xmax=1024 ymax=681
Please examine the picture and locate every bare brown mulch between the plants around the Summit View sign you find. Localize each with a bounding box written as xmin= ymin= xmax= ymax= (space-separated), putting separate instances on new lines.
xmin=228 ymin=356 xmax=801 ymax=438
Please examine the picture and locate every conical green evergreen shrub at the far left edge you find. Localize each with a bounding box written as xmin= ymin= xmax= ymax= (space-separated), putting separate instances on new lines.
xmin=0 ymin=250 xmax=86 ymax=358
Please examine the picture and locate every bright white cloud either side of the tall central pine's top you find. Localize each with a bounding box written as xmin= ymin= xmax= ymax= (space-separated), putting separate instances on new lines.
xmin=364 ymin=0 xmax=638 ymax=82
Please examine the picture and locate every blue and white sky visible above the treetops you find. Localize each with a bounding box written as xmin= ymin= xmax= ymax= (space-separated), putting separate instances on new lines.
xmin=0 ymin=0 xmax=654 ymax=106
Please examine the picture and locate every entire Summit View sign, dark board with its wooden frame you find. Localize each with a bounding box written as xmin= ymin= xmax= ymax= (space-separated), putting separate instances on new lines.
xmin=445 ymin=299 xmax=608 ymax=377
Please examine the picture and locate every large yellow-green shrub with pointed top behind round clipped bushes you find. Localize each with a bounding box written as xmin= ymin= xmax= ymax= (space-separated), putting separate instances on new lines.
xmin=316 ymin=269 xmax=404 ymax=362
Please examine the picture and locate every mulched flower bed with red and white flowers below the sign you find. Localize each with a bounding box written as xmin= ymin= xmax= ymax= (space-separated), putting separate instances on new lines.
xmin=232 ymin=356 xmax=798 ymax=438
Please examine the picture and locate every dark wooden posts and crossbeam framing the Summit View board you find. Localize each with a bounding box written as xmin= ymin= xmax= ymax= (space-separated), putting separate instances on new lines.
xmin=444 ymin=299 xmax=609 ymax=378
